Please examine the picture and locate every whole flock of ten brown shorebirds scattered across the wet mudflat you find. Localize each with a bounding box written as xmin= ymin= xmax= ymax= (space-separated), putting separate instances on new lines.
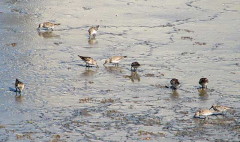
xmin=12 ymin=22 xmax=231 ymax=119
